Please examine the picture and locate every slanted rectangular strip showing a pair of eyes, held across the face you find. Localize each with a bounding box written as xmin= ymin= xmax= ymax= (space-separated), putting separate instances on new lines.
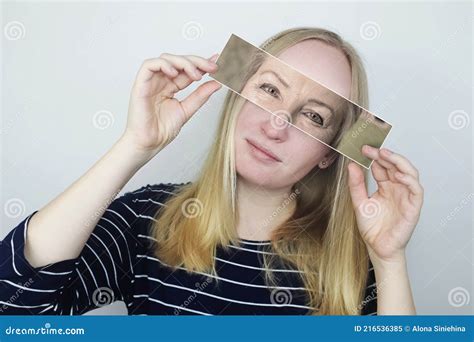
xmin=210 ymin=34 xmax=392 ymax=168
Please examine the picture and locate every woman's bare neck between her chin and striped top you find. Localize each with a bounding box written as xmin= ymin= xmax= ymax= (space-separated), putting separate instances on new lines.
xmin=236 ymin=176 xmax=296 ymax=240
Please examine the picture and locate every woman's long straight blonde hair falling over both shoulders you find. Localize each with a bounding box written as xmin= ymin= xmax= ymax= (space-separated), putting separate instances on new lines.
xmin=151 ymin=27 xmax=369 ymax=315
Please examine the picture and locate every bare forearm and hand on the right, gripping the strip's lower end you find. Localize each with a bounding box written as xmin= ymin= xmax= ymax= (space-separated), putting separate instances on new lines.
xmin=348 ymin=145 xmax=423 ymax=315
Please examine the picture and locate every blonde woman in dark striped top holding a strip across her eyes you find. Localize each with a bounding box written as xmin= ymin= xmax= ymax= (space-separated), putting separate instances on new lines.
xmin=0 ymin=28 xmax=423 ymax=315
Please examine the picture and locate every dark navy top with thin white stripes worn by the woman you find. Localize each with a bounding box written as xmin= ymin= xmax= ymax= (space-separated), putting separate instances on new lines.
xmin=0 ymin=183 xmax=377 ymax=315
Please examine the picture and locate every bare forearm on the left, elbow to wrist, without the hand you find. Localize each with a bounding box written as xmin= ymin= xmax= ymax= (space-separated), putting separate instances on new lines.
xmin=25 ymin=136 xmax=145 ymax=267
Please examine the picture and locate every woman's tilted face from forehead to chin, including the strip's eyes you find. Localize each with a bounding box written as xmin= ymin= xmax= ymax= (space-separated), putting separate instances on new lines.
xmin=235 ymin=39 xmax=351 ymax=189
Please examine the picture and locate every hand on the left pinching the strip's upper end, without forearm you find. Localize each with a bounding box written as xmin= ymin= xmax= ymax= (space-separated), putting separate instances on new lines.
xmin=122 ymin=53 xmax=221 ymax=160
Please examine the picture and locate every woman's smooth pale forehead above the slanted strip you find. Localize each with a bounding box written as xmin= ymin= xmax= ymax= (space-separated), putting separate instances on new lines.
xmin=260 ymin=39 xmax=351 ymax=98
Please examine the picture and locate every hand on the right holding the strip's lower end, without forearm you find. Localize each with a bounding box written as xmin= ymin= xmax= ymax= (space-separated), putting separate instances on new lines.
xmin=348 ymin=145 xmax=423 ymax=262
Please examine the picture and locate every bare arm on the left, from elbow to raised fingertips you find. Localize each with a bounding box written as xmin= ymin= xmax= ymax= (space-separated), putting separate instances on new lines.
xmin=25 ymin=54 xmax=220 ymax=267
